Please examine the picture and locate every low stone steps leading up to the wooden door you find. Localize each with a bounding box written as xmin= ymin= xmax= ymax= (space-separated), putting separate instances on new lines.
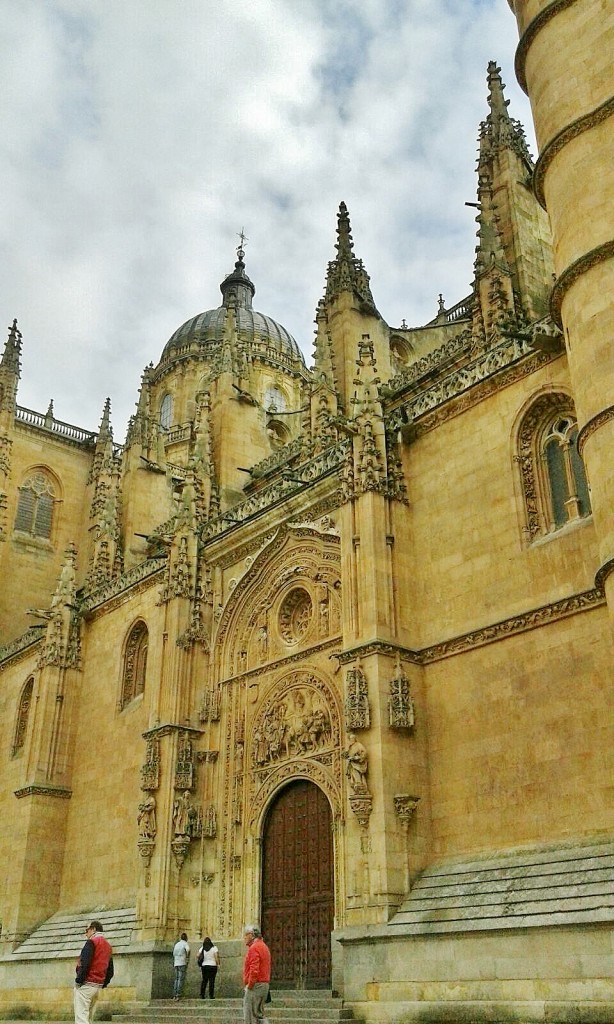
xmin=113 ymin=989 xmax=363 ymax=1024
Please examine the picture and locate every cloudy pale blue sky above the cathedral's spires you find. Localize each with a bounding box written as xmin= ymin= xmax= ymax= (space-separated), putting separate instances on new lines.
xmin=0 ymin=0 xmax=534 ymax=441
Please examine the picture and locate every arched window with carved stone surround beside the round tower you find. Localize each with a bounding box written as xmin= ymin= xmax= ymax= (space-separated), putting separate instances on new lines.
xmin=517 ymin=394 xmax=590 ymax=541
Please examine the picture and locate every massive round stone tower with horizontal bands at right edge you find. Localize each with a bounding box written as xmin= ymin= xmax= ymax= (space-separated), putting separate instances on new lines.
xmin=509 ymin=0 xmax=614 ymax=593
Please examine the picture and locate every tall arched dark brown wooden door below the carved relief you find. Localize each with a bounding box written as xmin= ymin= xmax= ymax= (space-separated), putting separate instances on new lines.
xmin=262 ymin=779 xmax=334 ymax=988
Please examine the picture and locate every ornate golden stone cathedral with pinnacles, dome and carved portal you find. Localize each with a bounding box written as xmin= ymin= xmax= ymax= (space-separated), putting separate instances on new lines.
xmin=0 ymin=9 xmax=614 ymax=1021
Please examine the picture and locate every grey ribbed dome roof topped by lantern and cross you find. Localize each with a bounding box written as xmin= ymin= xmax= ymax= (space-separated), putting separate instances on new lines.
xmin=162 ymin=251 xmax=305 ymax=366
